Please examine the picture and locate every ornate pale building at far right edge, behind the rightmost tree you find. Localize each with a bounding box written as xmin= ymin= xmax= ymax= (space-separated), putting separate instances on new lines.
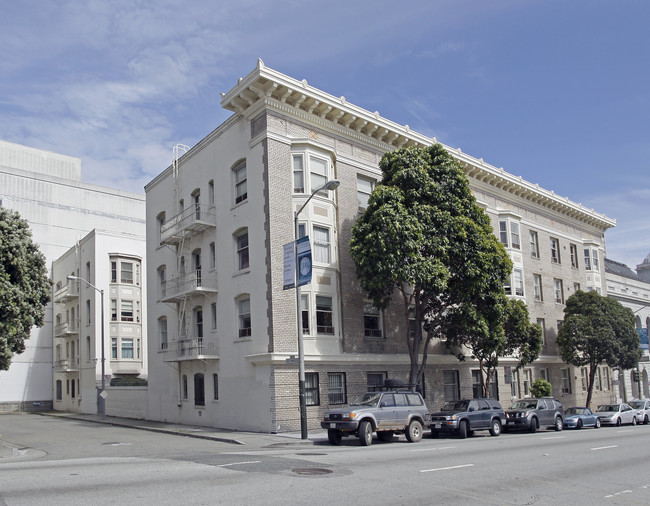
xmin=605 ymin=255 xmax=650 ymax=402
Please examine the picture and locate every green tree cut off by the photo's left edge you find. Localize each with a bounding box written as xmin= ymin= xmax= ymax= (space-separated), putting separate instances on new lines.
xmin=0 ymin=208 xmax=51 ymax=371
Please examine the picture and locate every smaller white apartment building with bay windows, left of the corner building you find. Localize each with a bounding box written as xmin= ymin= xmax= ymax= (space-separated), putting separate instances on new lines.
xmin=52 ymin=230 xmax=147 ymax=418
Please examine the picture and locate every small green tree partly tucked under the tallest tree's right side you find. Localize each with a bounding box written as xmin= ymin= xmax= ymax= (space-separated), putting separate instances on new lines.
xmin=445 ymin=296 xmax=542 ymax=397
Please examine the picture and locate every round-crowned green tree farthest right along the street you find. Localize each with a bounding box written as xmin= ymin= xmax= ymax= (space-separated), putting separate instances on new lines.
xmin=557 ymin=290 xmax=641 ymax=407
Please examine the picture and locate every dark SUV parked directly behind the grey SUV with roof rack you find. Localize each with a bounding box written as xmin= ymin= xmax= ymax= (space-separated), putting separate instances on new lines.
xmin=429 ymin=399 xmax=506 ymax=439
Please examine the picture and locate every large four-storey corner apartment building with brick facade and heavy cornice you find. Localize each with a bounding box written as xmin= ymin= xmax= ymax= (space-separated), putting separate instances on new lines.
xmin=145 ymin=61 xmax=616 ymax=432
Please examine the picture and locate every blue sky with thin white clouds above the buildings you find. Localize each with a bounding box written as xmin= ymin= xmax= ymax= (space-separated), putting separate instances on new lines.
xmin=0 ymin=0 xmax=650 ymax=267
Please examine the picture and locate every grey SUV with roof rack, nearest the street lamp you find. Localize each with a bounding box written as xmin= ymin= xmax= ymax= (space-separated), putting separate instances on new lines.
xmin=321 ymin=381 xmax=429 ymax=446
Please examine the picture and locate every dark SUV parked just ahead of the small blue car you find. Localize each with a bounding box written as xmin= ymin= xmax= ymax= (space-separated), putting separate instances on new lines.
xmin=504 ymin=397 xmax=564 ymax=432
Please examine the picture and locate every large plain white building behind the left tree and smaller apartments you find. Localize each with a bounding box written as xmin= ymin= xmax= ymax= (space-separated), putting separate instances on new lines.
xmin=0 ymin=141 xmax=145 ymax=411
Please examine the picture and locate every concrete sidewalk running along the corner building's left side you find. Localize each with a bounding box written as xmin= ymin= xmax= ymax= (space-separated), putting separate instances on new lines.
xmin=32 ymin=411 xmax=327 ymax=451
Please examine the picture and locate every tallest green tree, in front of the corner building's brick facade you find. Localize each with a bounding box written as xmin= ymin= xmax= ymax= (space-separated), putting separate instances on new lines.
xmin=350 ymin=144 xmax=512 ymax=387
